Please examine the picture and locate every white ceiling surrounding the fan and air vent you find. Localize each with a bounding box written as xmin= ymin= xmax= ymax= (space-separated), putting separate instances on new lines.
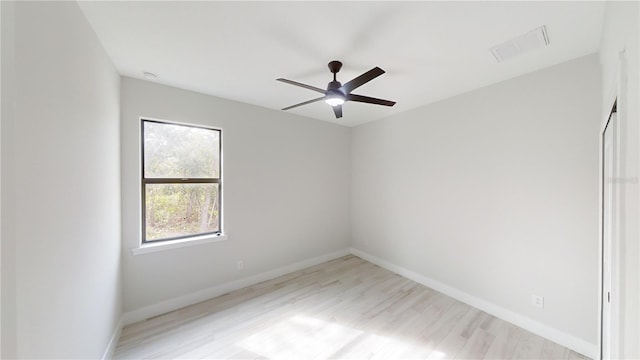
xmin=79 ymin=1 xmax=604 ymax=126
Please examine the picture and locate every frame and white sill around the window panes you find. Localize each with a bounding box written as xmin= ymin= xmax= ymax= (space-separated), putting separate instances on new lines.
xmin=139 ymin=117 xmax=222 ymax=245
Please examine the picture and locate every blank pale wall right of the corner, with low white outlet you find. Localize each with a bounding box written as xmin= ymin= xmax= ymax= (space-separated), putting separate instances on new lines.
xmin=352 ymin=55 xmax=601 ymax=351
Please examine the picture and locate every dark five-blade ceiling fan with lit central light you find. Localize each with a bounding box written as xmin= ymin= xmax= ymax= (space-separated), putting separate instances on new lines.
xmin=276 ymin=60 xmax=396 ymax=119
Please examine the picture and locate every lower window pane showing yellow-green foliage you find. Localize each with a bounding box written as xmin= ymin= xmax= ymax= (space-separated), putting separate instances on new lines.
xmin=145 ymin=184 xmax=220 ymax=241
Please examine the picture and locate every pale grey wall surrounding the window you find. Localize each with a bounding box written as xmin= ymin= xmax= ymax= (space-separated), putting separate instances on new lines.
xmin=121 ymin=77 xmax=350 ymax=312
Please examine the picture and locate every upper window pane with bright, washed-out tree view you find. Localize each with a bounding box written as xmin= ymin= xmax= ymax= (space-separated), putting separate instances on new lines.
xmin=143 ymin=121 xmax=220 ymax=178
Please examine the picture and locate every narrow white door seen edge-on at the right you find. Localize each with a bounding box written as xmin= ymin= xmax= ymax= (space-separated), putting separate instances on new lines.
xmin=602 ymin=113 xmax=618 ymax=359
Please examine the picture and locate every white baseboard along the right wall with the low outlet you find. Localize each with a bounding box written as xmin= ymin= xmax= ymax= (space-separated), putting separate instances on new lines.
xmin=351 ymin=248 xmax=598 ymax=359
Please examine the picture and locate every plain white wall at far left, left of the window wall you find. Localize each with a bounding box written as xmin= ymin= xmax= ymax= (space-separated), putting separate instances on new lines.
xmin=2 ymin=2 xmax=121 ymax=358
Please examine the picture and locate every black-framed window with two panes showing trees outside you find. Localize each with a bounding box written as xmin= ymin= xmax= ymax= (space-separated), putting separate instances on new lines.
xmin=141 ymin=119 xmax=222 ymax=243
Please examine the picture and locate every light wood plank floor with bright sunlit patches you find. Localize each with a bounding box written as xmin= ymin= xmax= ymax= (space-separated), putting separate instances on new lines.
xmin=115 ymin=256 xmax=584 ymax=360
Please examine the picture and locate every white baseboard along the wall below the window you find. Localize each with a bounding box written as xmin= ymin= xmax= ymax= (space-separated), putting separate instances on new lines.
xmin=123 ymin=248 xmax=350 ymax=325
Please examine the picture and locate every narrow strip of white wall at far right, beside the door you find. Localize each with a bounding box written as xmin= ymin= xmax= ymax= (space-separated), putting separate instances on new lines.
xmin=600 ymin=1 xmax=640 ymax=359
